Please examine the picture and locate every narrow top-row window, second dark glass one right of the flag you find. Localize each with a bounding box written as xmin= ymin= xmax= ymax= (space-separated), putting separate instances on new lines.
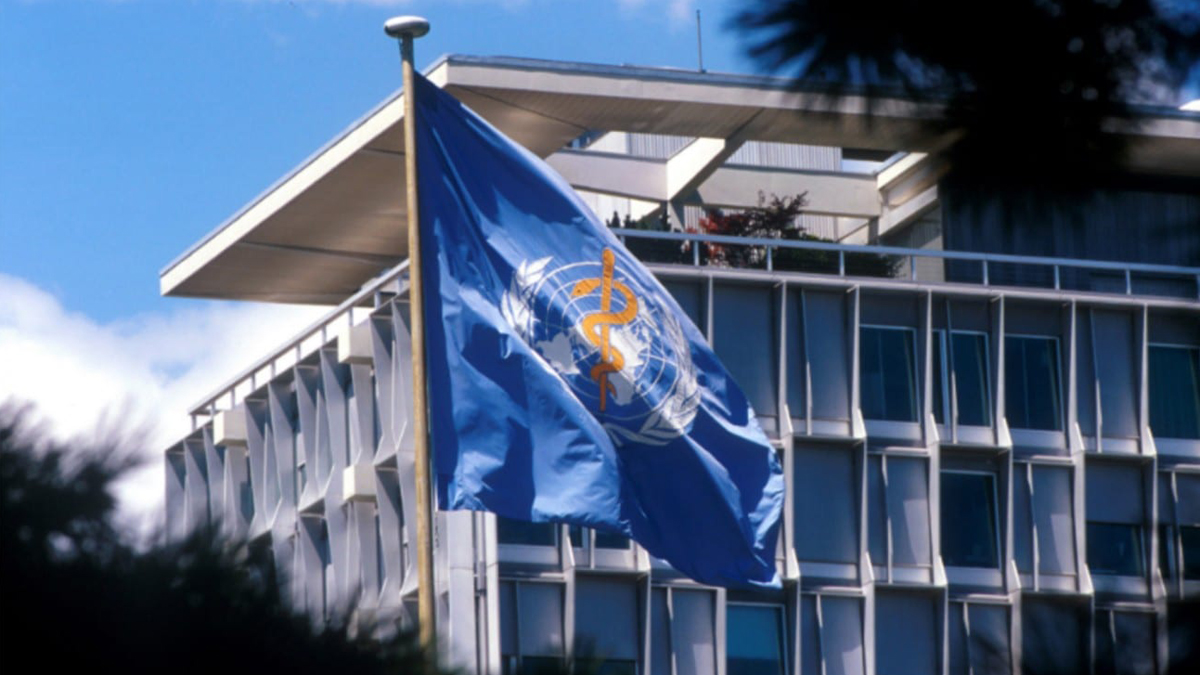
xmin=934 ymin=330 xmax=991 ymax=426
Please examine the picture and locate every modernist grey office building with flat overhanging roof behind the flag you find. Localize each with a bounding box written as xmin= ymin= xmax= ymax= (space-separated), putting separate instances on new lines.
xmin=162 ymin=56 xmax=1200 ymax=675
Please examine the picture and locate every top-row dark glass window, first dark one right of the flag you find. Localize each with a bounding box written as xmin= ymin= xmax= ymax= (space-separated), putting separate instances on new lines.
xmin=859 ymin=325 xmax=918 ymax=422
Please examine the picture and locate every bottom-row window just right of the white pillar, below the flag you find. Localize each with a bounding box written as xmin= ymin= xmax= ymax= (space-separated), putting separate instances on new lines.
xmin=500 ymin=581 xmax=565 ymax=675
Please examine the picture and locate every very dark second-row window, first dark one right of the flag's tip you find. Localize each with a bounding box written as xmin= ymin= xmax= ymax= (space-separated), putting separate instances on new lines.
xmin=942 ymin=471 xmax=1000 ymax=568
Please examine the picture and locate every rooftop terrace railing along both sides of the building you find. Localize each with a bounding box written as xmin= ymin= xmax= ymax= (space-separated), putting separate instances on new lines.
xmin=191 ymin=229 xmax=1200 ymax=424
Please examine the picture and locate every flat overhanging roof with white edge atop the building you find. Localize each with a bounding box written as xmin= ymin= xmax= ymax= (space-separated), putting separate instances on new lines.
xmin=160 ymin=55 xmax=1200 ymax=304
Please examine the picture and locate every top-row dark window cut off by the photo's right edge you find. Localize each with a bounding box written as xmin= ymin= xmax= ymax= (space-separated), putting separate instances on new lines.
xmin=1150 ymin=345 xmax=1200 ymax=438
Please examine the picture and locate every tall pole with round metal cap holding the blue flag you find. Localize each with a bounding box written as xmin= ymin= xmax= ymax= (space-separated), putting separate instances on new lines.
xmin=383 ymin=17 xmax=437 ymax=655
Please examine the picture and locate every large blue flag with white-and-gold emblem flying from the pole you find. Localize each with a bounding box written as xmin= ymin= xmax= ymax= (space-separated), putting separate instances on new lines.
xmin=413 ymin=76 xmax=784 ymax=587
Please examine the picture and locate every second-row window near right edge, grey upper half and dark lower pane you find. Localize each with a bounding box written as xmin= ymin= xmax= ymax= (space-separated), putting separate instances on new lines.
xmin=1087 ymin=464 xmax=1146 ymax=577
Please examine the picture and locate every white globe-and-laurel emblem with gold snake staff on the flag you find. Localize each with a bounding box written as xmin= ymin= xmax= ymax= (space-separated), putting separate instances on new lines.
xmin=500 ymin=249 xmax=700 ymax=446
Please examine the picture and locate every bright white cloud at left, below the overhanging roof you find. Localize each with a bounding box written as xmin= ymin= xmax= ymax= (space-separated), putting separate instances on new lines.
xmin=0 ymin=274 xmax=326 ymax=532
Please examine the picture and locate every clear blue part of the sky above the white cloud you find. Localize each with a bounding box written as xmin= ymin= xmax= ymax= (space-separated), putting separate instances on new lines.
xmin=0 ymin=0 xmax=749 ymax=321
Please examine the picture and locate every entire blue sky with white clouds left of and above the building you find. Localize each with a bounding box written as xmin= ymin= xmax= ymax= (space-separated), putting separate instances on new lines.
xmin=0 ymin=0 xmax=752 ymax=527
